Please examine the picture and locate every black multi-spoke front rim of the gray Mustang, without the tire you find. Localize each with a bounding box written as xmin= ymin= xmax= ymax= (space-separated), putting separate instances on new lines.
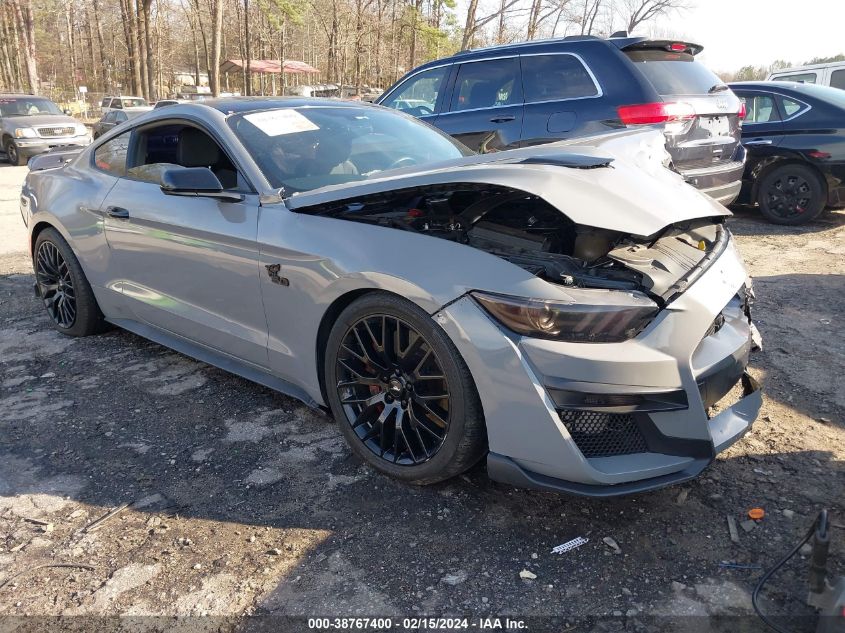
xmin=336 ymin=314 xmax=451 ymax=466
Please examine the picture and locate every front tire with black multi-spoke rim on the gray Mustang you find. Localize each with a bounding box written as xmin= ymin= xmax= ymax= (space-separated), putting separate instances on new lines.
xmin=324 ymin=292 xmax=487 ymax=485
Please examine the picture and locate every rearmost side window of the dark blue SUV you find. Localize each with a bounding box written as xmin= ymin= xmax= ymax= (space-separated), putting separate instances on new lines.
xmin=522 ymin=55 xmax=599 ymax=103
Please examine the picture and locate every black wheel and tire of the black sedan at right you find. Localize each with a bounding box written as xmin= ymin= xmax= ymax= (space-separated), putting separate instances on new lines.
xmin=757 ymin=163 xmax=826 ymax=226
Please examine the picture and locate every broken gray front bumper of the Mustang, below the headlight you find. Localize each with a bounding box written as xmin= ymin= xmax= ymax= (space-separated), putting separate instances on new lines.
xmin=436 ymin=231 xmax=762 ymax=496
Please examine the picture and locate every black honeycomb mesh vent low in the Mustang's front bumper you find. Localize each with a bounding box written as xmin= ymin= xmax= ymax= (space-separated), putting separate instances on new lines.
xmin=560 ymin=410 xmax=648 ymax=457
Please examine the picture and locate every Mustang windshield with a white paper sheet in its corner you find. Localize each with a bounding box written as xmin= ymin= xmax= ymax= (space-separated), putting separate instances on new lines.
xmin=229 ymin=106 xmax=472 ymax=195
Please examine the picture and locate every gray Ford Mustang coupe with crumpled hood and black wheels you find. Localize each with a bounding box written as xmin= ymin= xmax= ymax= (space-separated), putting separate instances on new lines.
xmin=21 ymin=98 xmax=761 ymax=496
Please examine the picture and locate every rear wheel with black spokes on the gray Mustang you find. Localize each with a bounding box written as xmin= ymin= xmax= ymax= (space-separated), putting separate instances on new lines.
xmin=32 ymin=228 xmax=105 ymax=336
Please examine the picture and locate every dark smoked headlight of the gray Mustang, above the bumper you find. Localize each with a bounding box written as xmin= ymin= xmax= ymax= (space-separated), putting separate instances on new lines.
xmin=472 ymin=289 xmax=658 ymax=343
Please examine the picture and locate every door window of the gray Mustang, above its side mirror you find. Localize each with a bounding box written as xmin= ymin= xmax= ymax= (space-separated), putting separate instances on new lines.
xmin=126 ymin=124 xmax=249 ymax=192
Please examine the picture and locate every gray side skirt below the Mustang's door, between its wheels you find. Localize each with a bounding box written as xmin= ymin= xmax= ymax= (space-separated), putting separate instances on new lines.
xmin=106 ymin=319 xmax=322 ymax=409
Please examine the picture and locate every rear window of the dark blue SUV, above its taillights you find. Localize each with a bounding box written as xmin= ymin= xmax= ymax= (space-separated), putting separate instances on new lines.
xmin=625 ymin=50 xmax=724 ymax=95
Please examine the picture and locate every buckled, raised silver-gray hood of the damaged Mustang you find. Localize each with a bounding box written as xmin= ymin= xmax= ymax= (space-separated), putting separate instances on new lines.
xmin=285 ymin=131 xmax=730 ymax=236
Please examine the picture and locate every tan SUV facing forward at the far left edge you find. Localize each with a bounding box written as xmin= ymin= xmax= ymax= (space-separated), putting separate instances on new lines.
xmin=0 ymin=94 xmax=91 ymax=165
